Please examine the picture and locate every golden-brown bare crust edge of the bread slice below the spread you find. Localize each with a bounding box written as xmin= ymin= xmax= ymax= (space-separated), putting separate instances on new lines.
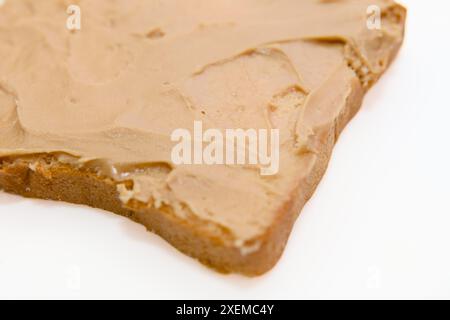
xmin=0 ymin=74 xmax=363 ymax=276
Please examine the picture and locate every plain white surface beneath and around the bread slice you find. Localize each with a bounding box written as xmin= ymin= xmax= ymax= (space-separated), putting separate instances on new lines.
xmin=0 ymin=0 xmax=450 ymax=299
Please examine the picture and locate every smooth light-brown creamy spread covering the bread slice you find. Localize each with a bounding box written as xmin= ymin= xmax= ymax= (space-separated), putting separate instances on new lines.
xmin=0 ymin=0 xmax=404 ymax=242
